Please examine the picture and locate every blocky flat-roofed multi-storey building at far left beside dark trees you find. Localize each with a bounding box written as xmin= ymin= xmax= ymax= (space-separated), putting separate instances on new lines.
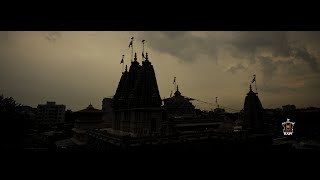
xmin=36 ymin=102 xmax=66 ymax=125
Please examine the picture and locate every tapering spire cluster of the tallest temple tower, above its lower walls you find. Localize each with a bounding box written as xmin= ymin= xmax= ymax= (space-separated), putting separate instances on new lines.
xmin=112 ymin=53 xmax=161 ymax=109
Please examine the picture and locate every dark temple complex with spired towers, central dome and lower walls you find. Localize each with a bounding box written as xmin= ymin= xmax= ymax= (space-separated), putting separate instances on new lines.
xmin=75 ymin=46 xmax=272 ymax=151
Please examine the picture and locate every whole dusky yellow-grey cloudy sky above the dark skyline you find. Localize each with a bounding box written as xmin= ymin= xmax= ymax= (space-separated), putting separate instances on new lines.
xmin=0 ymin=31 xmax=320 ymax=111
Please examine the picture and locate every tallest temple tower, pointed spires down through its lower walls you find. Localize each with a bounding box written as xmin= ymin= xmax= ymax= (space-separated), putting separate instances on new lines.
xmin=112 ymin=53 xmax=162 ymax=135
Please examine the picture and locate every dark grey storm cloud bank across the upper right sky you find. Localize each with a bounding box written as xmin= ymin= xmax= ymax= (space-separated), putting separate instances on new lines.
xmin=141 ymin=31 xmax=320 ymax=75
